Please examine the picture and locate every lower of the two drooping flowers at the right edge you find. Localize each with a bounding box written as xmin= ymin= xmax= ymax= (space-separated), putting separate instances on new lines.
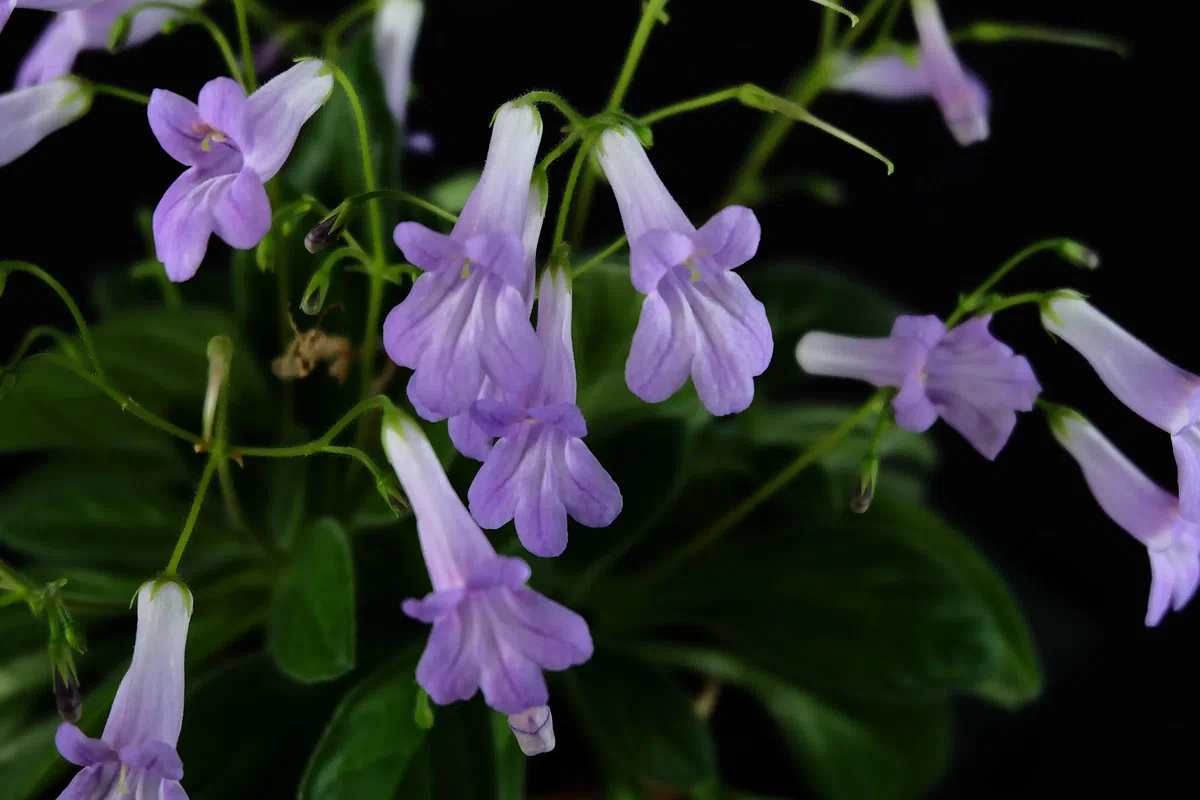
xmin=1051 ymin=413 xmax=1200 ymax=626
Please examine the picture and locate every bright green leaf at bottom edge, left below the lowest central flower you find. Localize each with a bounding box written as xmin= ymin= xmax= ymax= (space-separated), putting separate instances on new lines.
xmin=299 ymin=649 xmax=425 ymax=800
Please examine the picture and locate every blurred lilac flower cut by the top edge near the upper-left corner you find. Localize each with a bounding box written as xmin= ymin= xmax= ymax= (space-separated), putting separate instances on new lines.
xmin=17 ymin=0 xmax=204 ymax=88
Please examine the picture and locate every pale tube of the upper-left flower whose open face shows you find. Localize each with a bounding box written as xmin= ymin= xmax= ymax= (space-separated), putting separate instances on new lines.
xmin=242 ymin=59 xmax=334 ymax=182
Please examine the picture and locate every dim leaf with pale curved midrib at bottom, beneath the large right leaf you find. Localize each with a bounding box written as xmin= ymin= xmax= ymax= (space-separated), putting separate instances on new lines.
xmin=643 ymin=645 xmax=950 ymax=800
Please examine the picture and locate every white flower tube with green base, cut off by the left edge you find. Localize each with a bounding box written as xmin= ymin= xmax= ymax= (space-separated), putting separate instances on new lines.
xmin=0 ymin=77 xmax=92 ymax=167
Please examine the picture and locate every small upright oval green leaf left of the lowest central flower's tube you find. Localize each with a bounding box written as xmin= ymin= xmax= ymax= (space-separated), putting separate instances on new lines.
xmin=268 ymin=518 xmax=355 ymax=684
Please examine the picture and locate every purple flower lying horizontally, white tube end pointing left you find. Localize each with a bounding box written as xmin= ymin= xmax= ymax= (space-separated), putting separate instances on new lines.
xmin=796 ymin=315 xmax=1042 ymax=459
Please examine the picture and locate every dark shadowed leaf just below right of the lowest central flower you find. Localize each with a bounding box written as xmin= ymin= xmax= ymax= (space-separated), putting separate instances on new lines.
xmin=565 ymin=651 xmax=716 ymax=788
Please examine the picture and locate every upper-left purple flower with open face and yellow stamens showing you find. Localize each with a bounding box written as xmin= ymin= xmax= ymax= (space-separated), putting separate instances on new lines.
xmin=148 ymin=61 xmax=334 ymax=282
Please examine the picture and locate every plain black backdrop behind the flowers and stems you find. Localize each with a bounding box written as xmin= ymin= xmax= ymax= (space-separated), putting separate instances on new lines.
xmin=0 ymin=0 xmax=1185 ymax=798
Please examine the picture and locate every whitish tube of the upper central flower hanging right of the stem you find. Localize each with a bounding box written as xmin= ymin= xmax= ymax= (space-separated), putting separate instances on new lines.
xmin=596 ymin=128 xmax=696 ymax=242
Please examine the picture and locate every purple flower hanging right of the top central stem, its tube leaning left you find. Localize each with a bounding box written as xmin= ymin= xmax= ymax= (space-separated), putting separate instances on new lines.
xmin=598 ymin=128 xmax=774 ymax=416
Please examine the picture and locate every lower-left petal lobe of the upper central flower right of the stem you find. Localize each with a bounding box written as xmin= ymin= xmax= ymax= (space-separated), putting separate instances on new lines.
xmin=625 ymin=286 xmax=692 ymax=403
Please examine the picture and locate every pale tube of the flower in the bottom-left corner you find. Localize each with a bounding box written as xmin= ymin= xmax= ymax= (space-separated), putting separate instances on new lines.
xmin=101 ymin=582 xmax=192 ymax=751
